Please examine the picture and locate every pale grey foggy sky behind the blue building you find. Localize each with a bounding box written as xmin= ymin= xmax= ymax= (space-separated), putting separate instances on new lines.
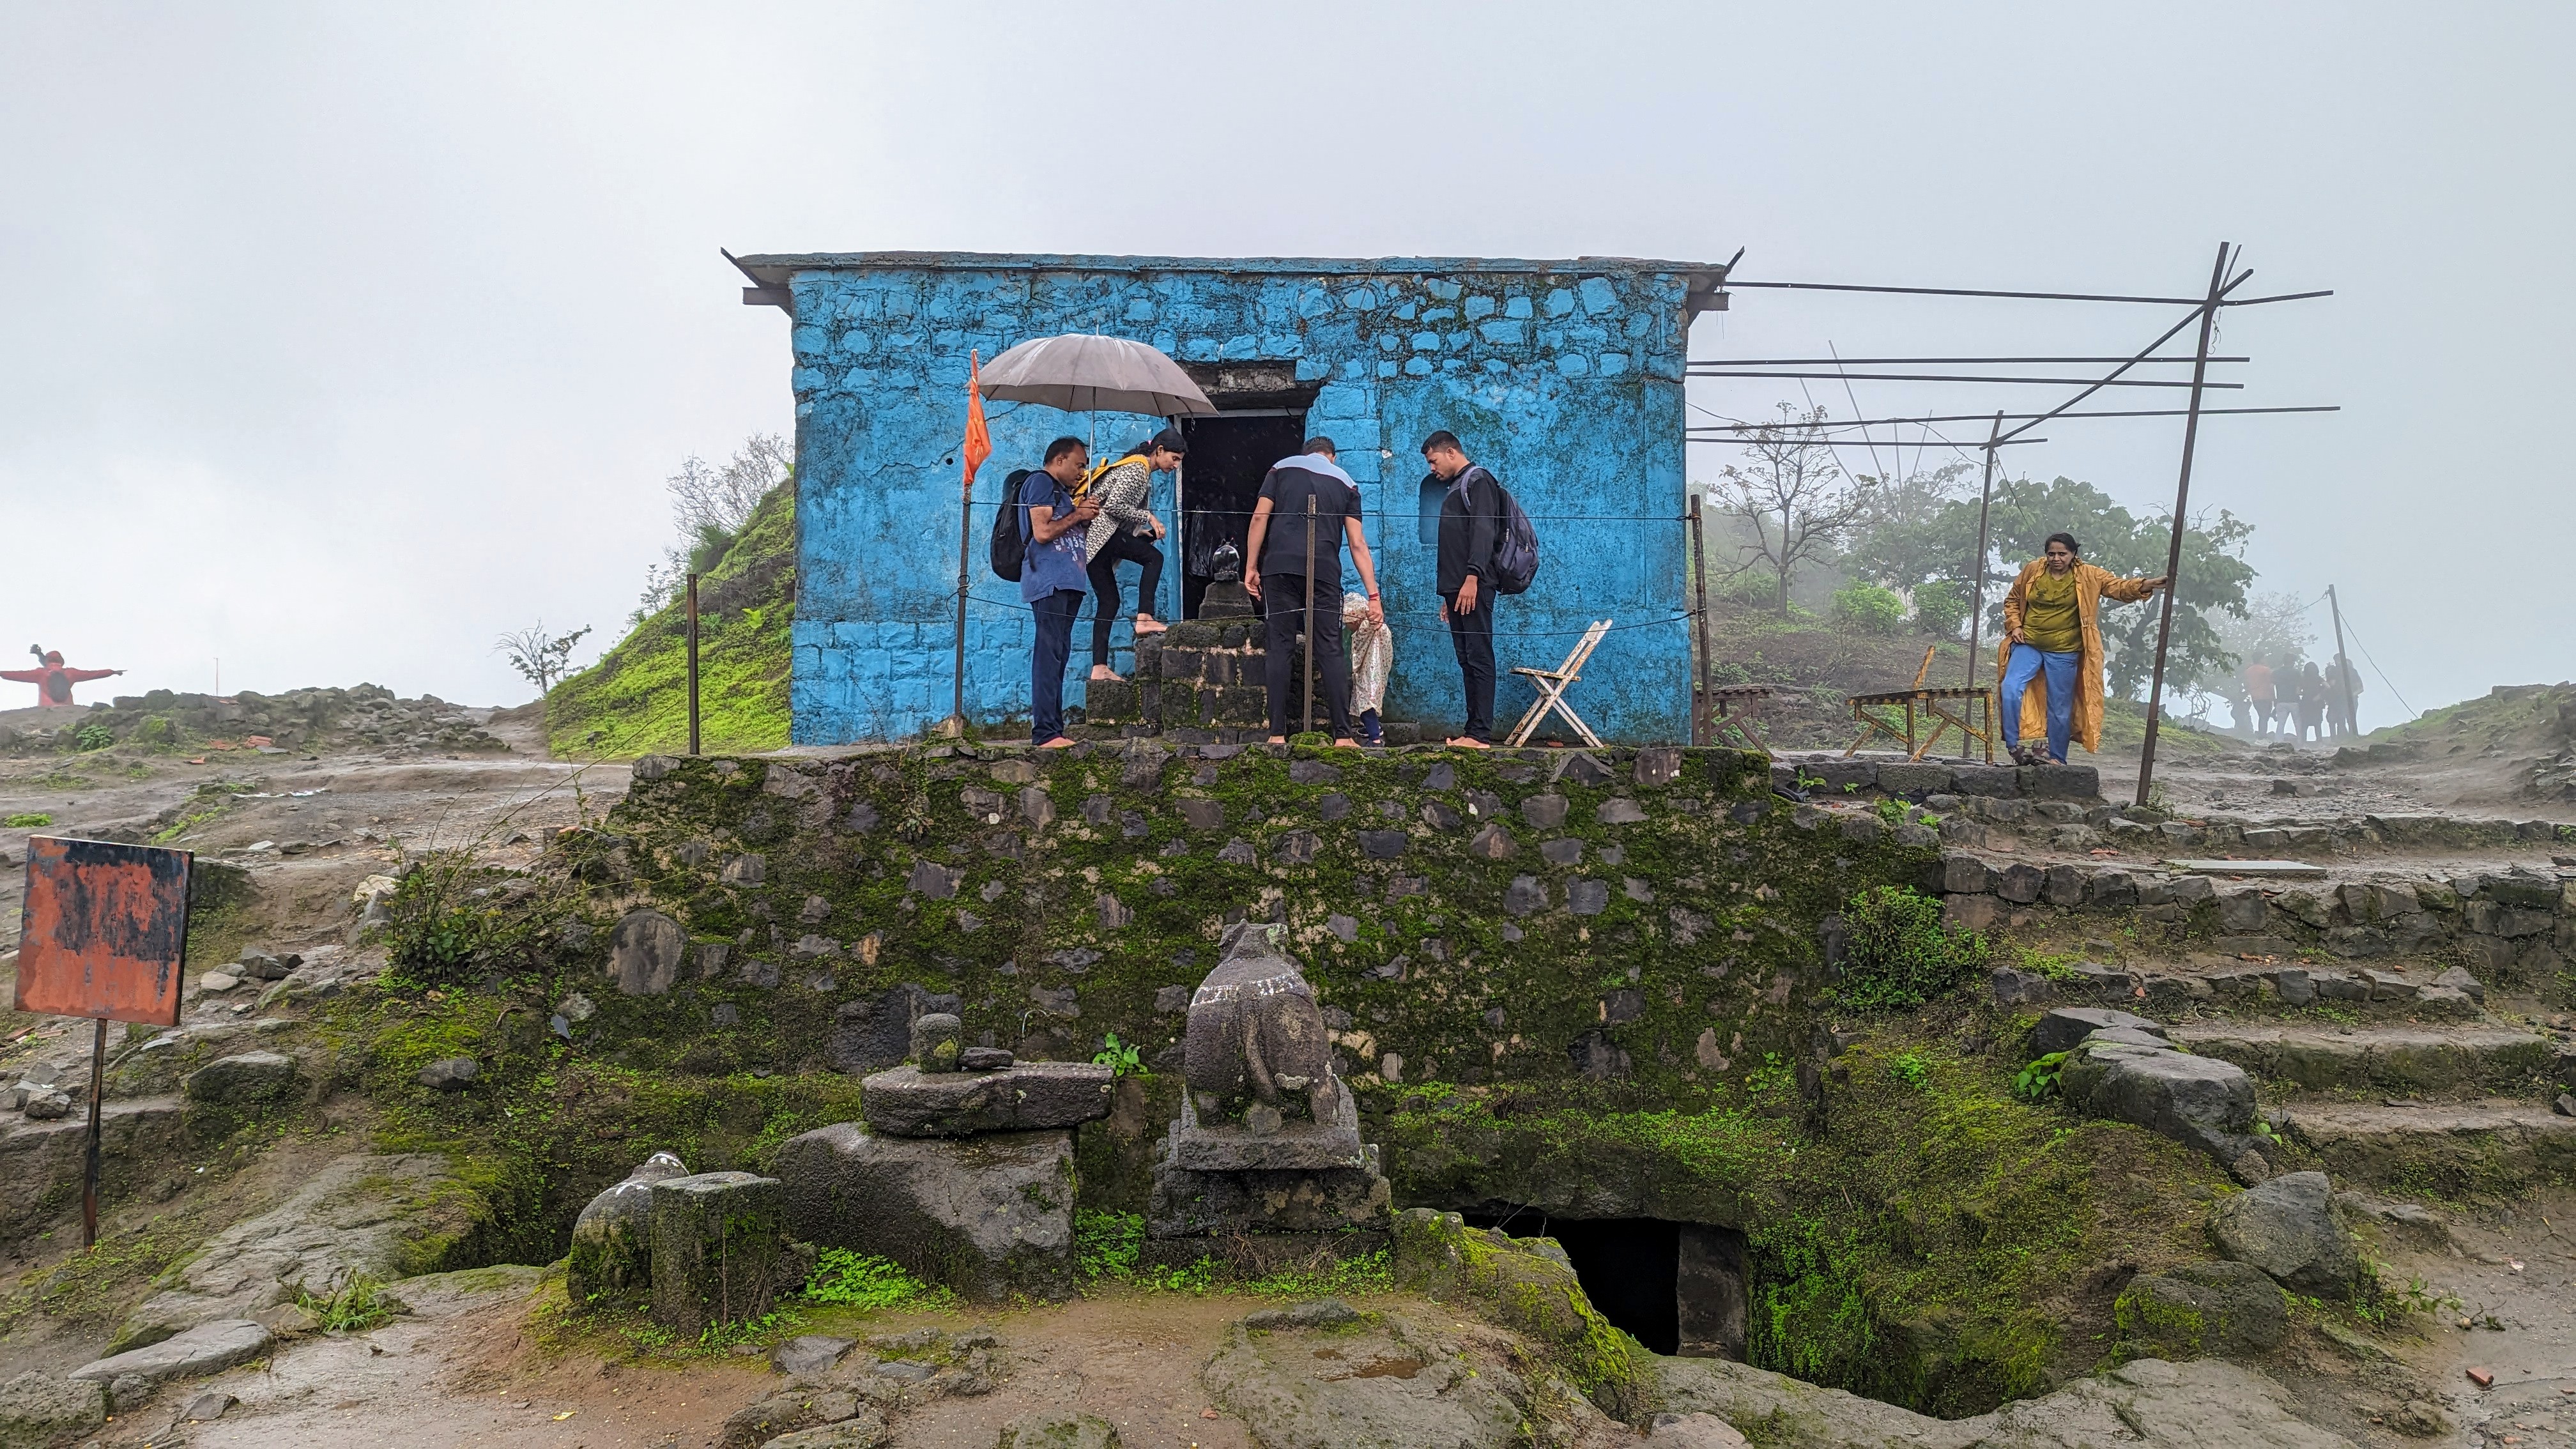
xmin=0 ymin=0 xmax=2576 ymax=724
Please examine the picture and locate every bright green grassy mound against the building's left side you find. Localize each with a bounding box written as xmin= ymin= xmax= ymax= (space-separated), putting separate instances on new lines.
xmin=546 ymin=482 xmax=796 ymax=758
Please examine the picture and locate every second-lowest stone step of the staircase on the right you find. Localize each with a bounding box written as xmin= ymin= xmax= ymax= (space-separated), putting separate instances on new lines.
xmin=2166 ymin=1021 xmax=2566 ymax=1093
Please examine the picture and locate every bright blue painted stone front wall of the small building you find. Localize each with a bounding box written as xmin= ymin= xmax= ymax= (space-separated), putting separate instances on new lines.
xmin=744 ymin=252 xmax=1698 ymax=745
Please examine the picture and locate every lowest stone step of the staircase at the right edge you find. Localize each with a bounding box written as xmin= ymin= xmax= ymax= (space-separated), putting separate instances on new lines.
xmin=2287 ymin=1098 xmax=2576 ymax=1197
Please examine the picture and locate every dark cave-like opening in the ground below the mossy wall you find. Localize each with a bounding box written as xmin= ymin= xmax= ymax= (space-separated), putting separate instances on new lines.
xmin=1466 ymin=1207 xmax=1744 ymax=1361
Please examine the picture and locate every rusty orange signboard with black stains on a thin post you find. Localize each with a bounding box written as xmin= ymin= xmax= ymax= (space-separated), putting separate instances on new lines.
xmin=18 ymin=836 xmax=193 ymax=1026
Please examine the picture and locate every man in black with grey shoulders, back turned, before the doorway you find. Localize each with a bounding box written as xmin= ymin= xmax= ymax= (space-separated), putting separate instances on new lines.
xmin=1244 ymin=438 xmax=1386 ymax=750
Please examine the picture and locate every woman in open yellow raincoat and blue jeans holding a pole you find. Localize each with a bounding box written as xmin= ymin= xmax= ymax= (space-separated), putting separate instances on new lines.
xmin=1994 ymin=533 xmax=2164 ymax=766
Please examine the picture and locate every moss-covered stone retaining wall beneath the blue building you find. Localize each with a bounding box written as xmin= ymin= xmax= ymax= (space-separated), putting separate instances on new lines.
xmin=567 ymin=740 xmax=1937 ymax=1106
